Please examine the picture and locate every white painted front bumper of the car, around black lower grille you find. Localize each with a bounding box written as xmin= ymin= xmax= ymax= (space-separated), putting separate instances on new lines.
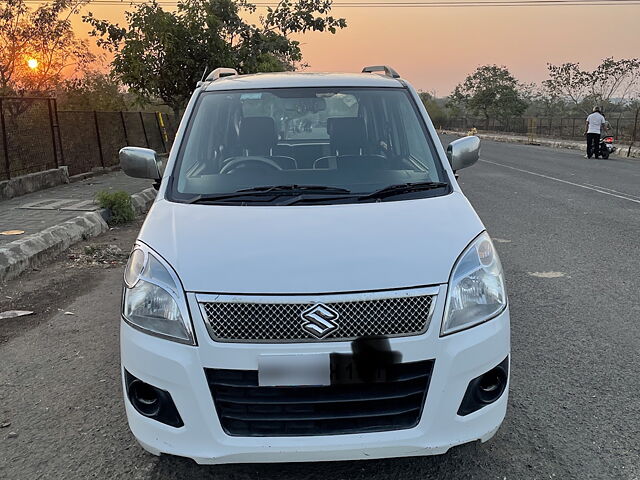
xmin=120 ymin=295 xmax=510 ymax=464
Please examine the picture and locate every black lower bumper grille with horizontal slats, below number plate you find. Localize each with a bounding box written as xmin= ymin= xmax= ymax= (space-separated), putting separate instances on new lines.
xmin=205 ymin=360 xmax=434 ymax=437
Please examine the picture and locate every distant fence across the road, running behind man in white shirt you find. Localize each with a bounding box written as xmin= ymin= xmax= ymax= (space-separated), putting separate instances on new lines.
xmin=437 ymin=116 xmax=640 ymax=142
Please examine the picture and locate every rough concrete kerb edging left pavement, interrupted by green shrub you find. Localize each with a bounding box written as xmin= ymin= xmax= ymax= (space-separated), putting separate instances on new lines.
xmin=0 ymin=188 xmax=156 ymax=282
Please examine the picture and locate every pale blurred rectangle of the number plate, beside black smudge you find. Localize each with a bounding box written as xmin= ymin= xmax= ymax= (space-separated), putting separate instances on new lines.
xmin=258 ymin=353 xmax=331 ymax=387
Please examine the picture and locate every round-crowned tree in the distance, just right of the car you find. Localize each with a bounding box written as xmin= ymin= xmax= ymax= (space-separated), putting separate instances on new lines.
xmin=449 ymin=65 xmax=527 ymax=126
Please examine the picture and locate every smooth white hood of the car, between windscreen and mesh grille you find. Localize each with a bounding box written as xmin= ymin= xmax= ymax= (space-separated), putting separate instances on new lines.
xmin=139 ymin=192 xmax=484 ymax=294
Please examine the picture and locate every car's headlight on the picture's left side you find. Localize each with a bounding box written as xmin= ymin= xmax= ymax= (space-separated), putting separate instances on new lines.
xmin=122 ymin=244 xmax=195 ymax=345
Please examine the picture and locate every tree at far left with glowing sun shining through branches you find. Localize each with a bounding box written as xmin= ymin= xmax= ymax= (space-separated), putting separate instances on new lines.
xmin=0 ymin=0 xmax=95 ymax=95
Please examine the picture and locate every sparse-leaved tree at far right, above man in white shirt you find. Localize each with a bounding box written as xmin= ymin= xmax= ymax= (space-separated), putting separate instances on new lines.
xmin=543 ymin=57 xmax=640 ymax=113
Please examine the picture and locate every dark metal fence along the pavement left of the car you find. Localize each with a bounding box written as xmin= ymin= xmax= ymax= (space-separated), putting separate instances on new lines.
xmin=0 ymin=97 xmax=178 ymax=180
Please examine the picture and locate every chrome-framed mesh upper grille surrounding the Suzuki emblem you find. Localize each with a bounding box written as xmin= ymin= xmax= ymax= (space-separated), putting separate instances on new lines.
xmin=198 ymin=288 xmax=437 ymax=343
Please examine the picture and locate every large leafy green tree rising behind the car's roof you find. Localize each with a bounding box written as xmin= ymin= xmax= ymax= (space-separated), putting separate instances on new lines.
xmin=84 ymin=0 xmax=346 ymax=113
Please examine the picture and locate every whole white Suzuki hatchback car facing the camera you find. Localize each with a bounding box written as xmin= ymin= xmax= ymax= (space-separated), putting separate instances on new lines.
xmin=120 ymin=67 xmax=510 ymax=464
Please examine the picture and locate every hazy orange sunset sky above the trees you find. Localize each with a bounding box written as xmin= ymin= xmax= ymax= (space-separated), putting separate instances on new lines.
xmin=76 ymin=3 xmax=640 ymax=96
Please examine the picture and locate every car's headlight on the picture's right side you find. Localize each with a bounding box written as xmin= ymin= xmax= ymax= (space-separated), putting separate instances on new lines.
xmin=441 ymin=232 xmax=507 ymax=335
